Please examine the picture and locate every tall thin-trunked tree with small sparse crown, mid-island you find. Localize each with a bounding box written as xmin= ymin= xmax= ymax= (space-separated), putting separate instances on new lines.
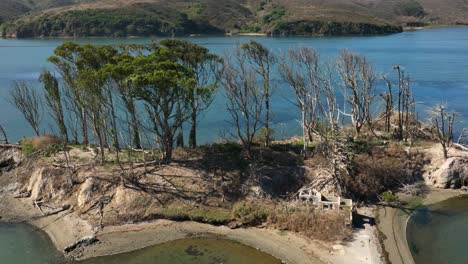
xmin=241 ymin=40 xmax=277 ymax=146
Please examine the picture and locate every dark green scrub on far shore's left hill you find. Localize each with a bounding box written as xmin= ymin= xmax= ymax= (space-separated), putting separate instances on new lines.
xmin=4 ymin=6 xmax=196 ymax=38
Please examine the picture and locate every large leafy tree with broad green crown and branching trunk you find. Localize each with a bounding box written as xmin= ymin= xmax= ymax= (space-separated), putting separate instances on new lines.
xmin=130 ymin=46 xmax=196 ymax=162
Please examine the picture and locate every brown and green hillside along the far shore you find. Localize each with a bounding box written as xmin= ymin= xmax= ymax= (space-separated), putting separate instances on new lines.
xmin=0 ymin=0 xmax=468 ymax=37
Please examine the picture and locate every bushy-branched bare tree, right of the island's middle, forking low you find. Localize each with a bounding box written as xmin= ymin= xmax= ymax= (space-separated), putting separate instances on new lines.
xmin=337 ymin=50 xmax=375 ymax=137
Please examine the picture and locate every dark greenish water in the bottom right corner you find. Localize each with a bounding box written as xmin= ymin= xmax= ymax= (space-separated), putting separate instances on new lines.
xmin=407 ymin=197 xmax=468 ymax=264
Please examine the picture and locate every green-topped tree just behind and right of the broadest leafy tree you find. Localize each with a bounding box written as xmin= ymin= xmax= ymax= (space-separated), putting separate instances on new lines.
xmin=159 ymin=39 xmax=222 ymax=148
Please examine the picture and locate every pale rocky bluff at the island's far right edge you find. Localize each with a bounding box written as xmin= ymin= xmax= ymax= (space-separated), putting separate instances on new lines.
xmin=425 ymin=157 xmax=468 ymax=189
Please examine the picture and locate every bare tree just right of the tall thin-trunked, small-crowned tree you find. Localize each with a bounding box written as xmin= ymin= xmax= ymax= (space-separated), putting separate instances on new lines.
xmin=280 ymin=48 xmax=321 ymax=152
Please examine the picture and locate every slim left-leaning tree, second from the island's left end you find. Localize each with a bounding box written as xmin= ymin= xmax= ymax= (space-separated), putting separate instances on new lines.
xmin=39 ymin=70 xmax=68 ymax=142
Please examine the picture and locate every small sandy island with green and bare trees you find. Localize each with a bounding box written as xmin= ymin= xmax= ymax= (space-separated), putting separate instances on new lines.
xmin=0 ymin=39 xmax=468 ymax=263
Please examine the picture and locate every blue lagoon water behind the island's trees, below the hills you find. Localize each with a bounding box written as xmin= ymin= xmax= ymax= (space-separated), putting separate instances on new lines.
xmin=0 ymin=28 xmax=468 ymax=143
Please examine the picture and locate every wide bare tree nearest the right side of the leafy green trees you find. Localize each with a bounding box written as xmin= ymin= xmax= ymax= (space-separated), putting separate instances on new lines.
xmin=221 ymin=48 xmax=265 ymax=157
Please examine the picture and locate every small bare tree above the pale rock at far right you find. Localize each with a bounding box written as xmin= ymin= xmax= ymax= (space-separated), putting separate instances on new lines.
xmin=430 ymin=104 xmax=455 ymax=159
